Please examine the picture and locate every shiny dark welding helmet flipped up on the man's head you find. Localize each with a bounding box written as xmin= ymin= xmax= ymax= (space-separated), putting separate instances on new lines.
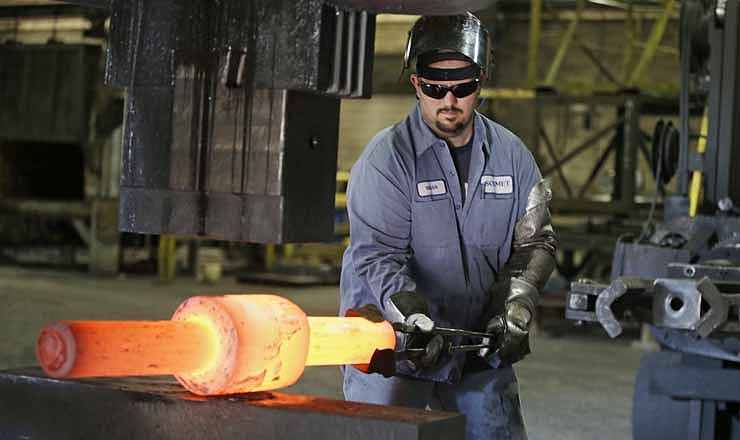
xmin=403 ymin=12 xmax=493 ymax=81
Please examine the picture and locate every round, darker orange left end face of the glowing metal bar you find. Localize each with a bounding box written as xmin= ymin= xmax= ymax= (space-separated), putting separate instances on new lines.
xmin=36 ymin=321 xmax=77 ymax=378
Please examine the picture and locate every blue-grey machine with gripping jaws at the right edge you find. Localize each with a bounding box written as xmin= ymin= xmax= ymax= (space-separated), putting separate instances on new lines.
xmin=566 ymin=0 xmax=740 ymax=440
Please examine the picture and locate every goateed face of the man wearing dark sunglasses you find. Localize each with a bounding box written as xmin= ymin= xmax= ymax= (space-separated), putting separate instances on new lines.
xmin=411 ymin=60 xmax=480 ymax=138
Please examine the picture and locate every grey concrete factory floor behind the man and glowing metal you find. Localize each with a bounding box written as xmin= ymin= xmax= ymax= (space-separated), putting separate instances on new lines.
xmin=0 ymin=267 xmax=640 ymax=440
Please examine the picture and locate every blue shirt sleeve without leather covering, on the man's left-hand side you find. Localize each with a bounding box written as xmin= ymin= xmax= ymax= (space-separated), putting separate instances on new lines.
xmin=347 ymin=148 xmax=416 ymax=309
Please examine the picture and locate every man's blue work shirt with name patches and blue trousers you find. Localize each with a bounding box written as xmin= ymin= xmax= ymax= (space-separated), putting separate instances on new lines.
xmin=340 ymin=104 xmax=541 ymax=440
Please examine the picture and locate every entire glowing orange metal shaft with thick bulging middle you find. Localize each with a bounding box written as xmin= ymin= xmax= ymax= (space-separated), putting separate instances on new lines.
xmin=36 ymin=295 xmax=396 ymax=395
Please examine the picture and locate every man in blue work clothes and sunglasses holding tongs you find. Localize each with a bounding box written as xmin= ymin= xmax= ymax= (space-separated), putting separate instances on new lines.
xmin=340 ymin=14 xmax=555 ymax=440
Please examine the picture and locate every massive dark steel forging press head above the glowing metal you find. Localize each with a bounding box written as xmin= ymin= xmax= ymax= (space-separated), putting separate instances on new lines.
xmin=99 ymin=0 xmax=490 ymax=243
